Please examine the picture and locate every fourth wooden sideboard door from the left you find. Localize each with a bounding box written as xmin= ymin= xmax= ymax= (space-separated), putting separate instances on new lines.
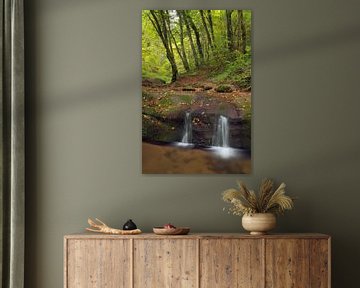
xmin=265 ymin=239 xmax=311 ymax=288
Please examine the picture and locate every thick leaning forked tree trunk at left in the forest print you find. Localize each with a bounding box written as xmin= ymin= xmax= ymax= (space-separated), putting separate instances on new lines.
xmin=149 ymin=10 xmax=179 ymax=82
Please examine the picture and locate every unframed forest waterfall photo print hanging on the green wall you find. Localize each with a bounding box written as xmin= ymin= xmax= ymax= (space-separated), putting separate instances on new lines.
xmin=142 ymin=10 xmax=252 ymax=174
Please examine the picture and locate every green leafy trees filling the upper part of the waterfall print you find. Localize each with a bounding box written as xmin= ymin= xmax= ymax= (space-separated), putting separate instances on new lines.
xmin=142 ymin=10 xmax=251 ymax=86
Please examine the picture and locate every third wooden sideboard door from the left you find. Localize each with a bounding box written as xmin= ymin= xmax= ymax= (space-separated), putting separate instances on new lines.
xmin=200 ymin=239 xmax=264 ymax=288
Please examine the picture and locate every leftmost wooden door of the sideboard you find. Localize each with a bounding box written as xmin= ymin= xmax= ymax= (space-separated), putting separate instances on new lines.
xmin=65 ymin=239 xmax=131 ymax=288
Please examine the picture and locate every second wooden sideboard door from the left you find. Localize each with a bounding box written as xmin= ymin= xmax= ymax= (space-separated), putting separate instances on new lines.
xmin=134 ymin=239 xmax=198 ymax=288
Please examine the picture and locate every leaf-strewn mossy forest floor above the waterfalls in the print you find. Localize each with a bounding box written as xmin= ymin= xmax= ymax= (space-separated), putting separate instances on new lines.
xmin=142 ymin=70 xmax=251 ymax=124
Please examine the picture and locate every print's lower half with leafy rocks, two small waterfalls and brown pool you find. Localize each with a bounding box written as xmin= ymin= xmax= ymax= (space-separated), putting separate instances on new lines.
xmin=142 ymin=74 xmax=251 ymax=174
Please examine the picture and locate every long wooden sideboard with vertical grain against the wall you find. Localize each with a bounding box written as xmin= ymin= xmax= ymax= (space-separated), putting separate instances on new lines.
xmin=64 ymin=233 xmax=331 ymax=288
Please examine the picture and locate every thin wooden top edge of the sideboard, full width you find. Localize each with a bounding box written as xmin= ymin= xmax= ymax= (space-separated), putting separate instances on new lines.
xmin=64 ymin=232 xmax=330 ymax=239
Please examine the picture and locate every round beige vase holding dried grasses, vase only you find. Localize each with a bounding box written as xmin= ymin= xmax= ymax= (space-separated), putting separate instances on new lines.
xmin=242 ymin=213 xmax=276 ymax=235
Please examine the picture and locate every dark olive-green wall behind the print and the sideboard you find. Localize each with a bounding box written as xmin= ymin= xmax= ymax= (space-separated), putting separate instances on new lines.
xmin=26 ymin=0 xmax=360 ymax=288
